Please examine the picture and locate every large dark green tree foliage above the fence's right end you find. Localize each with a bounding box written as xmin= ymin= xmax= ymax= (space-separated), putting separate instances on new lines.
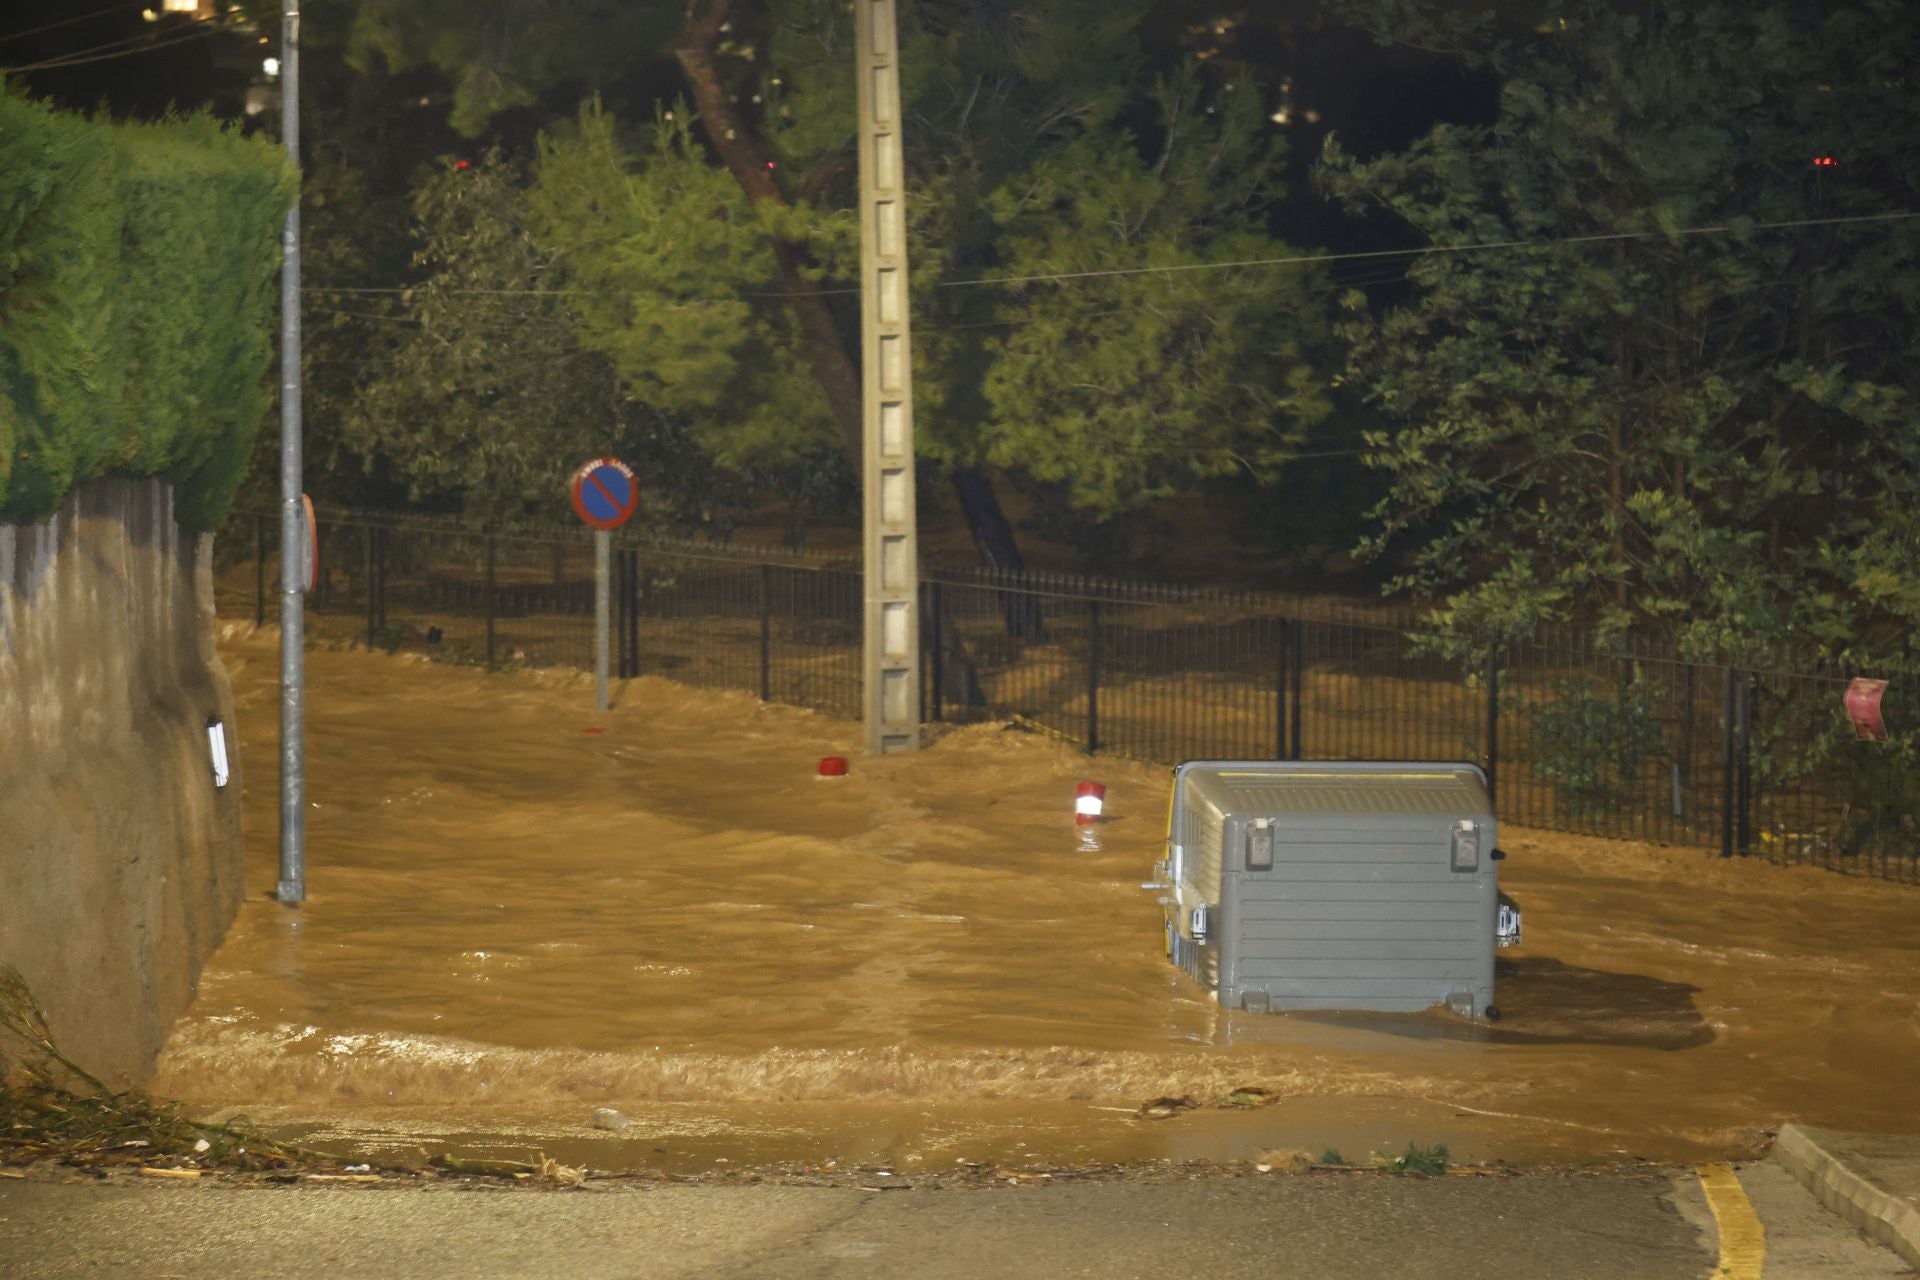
xmin=1325 ymin=0 xmax=1920 ymax=654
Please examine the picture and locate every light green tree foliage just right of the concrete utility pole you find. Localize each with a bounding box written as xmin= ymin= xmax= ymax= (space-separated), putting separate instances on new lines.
xmin=973 ymin=77 xmax=1329 ymax=518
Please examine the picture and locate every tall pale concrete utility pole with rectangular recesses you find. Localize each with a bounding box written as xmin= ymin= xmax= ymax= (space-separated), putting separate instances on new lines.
xmin=854 ymin=0 xmax=920 ymax=754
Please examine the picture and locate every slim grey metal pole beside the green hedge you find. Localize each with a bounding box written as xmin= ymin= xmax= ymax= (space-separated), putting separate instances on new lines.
xmin=275 ymin=0 xmax=307 ymax=904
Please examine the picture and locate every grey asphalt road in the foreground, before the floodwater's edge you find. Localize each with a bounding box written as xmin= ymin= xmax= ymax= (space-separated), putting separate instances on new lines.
xmin=0 ymin=1165 xmax=1912 ymax=1280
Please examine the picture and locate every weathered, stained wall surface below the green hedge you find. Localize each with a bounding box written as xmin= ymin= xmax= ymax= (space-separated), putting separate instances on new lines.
xmin=0 ymin=480 xmax=242 ymax=1084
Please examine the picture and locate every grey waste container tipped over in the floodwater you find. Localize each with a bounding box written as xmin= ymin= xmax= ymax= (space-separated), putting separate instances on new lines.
xmin=1152 ymin=760 xmax=1521 ymax=1019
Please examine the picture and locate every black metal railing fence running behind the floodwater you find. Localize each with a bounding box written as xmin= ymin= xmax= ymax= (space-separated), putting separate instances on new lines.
xmin=219 ymin=516 xmax=1920 ymax=881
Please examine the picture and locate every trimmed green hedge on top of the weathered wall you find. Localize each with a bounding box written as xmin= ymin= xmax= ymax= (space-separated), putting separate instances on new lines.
xmin=0 ymin=94 xmax=296 ymax=532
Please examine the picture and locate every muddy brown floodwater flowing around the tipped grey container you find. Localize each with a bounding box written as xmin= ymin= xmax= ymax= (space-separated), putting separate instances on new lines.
xmin=154 ymin=628 xmax=1920 ymax=1169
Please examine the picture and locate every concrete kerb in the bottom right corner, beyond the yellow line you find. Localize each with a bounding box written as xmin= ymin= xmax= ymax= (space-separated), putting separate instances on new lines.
xmin=1774 ymin=1125 xmax=1920 ymax=1268
